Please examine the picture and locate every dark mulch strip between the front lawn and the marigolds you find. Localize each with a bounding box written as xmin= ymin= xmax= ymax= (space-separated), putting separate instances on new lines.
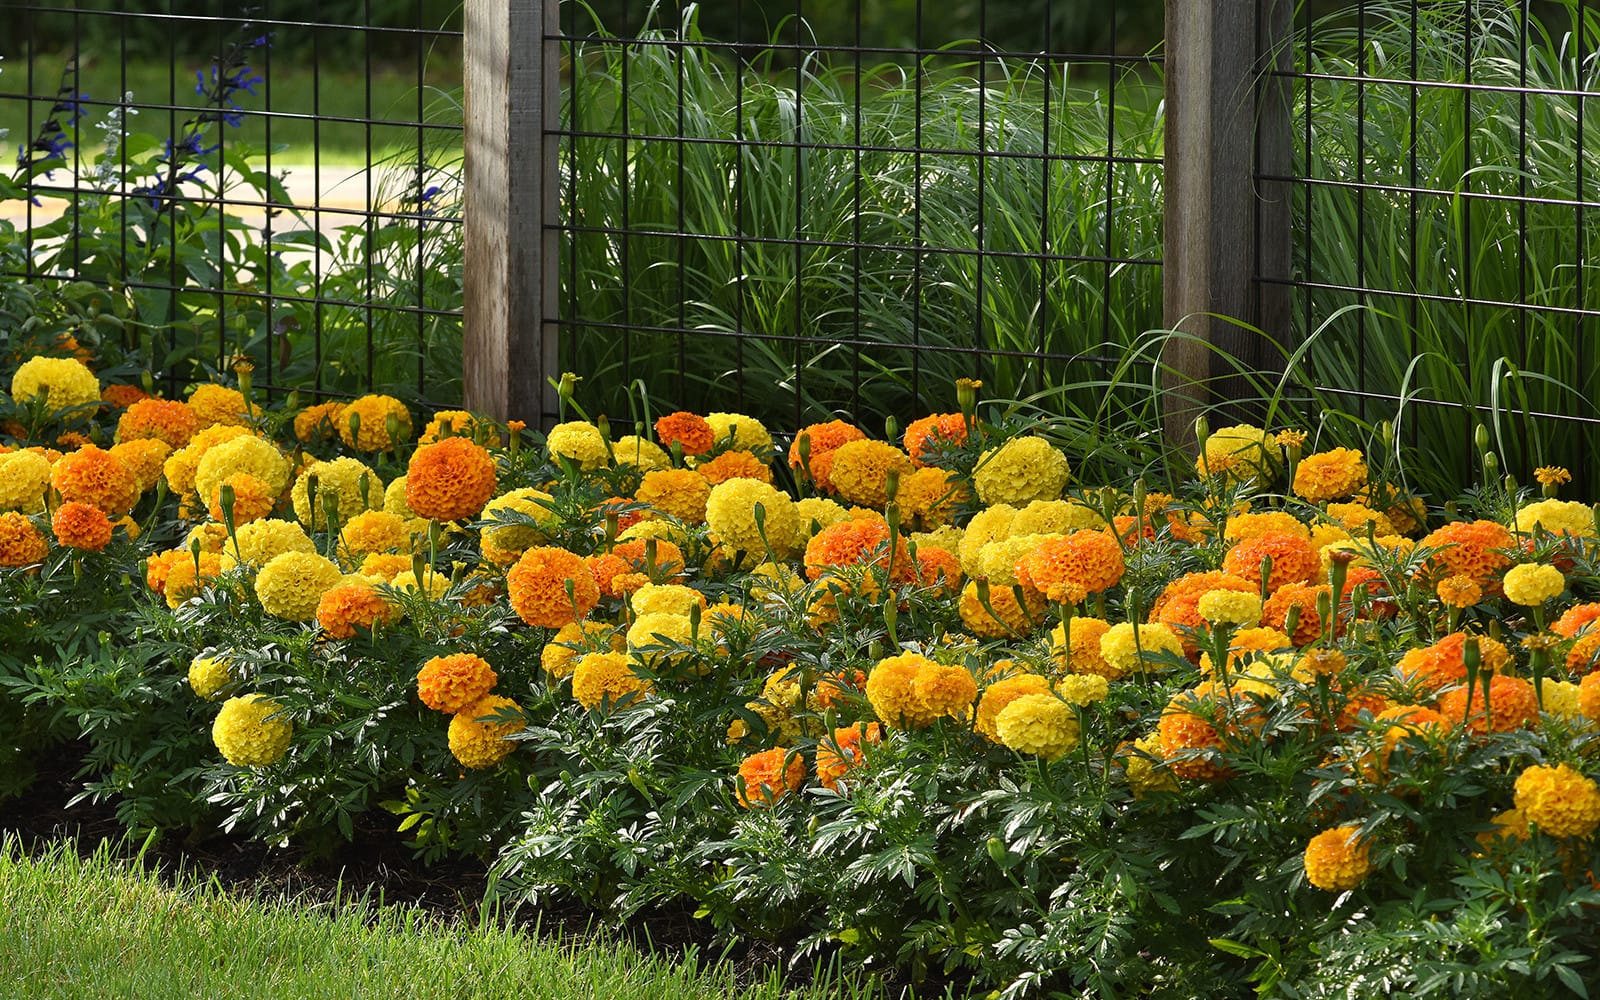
xmin=0 ymin=744 xmax=803 ymax=978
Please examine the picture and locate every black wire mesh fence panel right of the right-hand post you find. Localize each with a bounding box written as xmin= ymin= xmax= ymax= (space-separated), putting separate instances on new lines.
xmin=1259 ymin=0 xmax=1600 ymax=491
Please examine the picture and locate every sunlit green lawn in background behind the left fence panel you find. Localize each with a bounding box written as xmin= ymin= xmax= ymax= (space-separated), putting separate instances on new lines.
xmin=0 ymin=51 xmax=461 ymax=170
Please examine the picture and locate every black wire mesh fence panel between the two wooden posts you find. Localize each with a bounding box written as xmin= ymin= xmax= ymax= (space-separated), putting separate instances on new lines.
xmin=547 ymin=0 xmax=1162 ymax=426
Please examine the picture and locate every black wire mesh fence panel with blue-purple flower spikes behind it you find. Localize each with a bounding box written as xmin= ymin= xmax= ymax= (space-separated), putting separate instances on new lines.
xmin=0 ymin=0 xmax=462 ymax=402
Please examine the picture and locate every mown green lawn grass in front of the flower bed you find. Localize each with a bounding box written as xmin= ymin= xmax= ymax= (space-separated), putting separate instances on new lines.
xmin=0 ymin=837 xmax=902 ymax=1000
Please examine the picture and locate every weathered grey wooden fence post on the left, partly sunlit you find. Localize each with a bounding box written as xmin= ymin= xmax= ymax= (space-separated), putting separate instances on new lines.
xmin=461 ymin=0 xmax=560 ymax=426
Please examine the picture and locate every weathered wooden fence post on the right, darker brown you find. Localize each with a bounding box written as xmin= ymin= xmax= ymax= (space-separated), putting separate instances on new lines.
xmin=1162 ymin=0 xmax=1294 ymax=450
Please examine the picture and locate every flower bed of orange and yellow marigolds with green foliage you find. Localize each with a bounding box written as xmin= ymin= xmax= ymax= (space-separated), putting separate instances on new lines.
xmin=0 ymin=347 xmax=1600 ymax=997
